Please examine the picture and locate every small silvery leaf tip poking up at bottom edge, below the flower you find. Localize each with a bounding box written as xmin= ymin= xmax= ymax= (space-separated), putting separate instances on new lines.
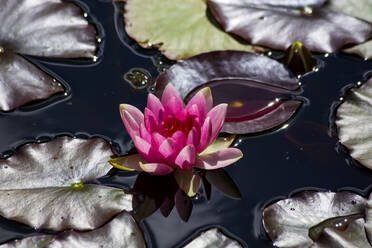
xmin=184 ymin=228 xmax=243 ymax=248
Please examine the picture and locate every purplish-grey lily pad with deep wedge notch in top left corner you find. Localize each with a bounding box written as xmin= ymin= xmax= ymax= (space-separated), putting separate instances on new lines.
xmin=0 ymin=0 xmax=97 ymax=111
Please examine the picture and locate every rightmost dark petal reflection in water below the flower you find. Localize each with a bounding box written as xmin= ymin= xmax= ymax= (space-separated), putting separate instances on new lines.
xmin=205 ymin=169 xmax=243 ymax=199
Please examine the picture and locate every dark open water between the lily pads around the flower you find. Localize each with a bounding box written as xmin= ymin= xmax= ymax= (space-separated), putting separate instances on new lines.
xmin=0 ymin=0 xmax=372 ymax=248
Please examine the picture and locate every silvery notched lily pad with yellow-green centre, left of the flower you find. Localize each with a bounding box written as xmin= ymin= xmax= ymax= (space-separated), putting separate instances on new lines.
xmin=0 ymin=137 xmax=132 ymax=231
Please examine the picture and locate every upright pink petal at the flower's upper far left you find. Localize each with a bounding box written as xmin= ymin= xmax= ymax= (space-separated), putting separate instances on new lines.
xmin=120 ymin=104 xmax=144 ymax=139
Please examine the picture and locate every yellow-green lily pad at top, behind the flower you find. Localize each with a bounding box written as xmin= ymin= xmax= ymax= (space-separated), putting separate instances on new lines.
xmin=124 ymin=0 xmax=254 ymax=60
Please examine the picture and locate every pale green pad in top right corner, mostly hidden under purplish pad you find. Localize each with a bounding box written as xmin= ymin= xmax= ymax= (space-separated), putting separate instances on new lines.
xmin=326 ymin=0 xmax=372 ymax=59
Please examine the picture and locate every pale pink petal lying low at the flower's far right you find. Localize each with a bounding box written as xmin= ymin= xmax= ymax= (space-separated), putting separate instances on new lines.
xmin=194 ymin=148 xmax=243 ymax=170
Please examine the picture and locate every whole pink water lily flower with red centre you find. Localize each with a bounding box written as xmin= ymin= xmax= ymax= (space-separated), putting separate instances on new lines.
xmin=110 ymin=84 xmax=242 ymax=194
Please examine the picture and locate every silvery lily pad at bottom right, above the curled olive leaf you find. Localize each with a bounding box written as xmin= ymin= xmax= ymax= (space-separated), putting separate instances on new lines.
xmin=263 ymin=191 xmax=366 ymax=248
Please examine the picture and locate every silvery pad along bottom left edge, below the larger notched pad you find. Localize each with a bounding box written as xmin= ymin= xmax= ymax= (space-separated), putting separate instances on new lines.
xmin=0 ymin=212 xmax=146 ymax=248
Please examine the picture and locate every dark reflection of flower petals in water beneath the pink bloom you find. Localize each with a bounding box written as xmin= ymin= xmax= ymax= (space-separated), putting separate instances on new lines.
xmin=132 ymin=169 xmax=242 ymax=222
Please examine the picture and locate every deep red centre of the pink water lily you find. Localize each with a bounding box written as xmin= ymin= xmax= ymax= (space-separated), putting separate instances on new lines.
xmin=161 ymin=116 xmax=193 ymax=137
